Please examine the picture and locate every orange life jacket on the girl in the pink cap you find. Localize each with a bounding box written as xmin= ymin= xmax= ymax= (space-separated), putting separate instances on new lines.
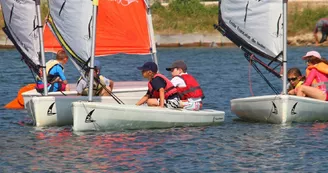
xmin=306 ymin=62 xmax=328 ymax=89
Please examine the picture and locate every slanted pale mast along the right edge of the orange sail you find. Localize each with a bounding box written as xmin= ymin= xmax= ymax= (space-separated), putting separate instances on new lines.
xmin=144 ymin=0 xmax=158 ymax=65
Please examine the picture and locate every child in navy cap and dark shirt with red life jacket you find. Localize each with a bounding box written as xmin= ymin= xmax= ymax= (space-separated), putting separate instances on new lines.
xmin=136 ymin=62 xmax=179 ymax=108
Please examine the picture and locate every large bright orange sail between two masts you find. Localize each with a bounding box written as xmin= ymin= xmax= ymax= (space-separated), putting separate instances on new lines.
xmin=96 ymin=0 xmax=151 ymax=56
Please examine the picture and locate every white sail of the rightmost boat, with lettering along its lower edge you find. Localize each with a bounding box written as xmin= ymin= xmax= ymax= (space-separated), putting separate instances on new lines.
xmin=219 ymin=0 xmax=283 ymax=61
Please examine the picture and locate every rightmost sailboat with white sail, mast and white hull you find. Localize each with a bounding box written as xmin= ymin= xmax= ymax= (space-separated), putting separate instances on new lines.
xmin=216 ymin=0 xmax=328 ymax=124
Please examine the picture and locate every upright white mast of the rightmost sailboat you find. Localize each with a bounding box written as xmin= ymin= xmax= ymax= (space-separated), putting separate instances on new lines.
xmin=282 ymin=0 xmax=288 ymax=94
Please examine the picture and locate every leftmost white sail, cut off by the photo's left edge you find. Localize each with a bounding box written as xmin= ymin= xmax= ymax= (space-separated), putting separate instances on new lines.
xmin=0 ymin=0 xmax=40 ymax=74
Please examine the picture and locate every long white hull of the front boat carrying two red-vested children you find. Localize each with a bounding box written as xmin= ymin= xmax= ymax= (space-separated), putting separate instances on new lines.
xmin=72 ymin=101 xmax=225 ymax=131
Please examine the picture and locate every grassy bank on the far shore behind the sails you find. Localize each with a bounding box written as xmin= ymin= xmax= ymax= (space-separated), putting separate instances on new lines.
xmin=0 ymin=0 xmax=328 ymax=35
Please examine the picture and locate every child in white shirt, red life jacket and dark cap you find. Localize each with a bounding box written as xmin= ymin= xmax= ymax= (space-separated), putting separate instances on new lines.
xmin=166 ymin=60 xmax=204 ymax=111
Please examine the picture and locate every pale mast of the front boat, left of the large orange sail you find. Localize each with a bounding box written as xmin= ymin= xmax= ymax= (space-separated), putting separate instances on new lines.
xmin=88 ymin=0 xmax=99 ymax=102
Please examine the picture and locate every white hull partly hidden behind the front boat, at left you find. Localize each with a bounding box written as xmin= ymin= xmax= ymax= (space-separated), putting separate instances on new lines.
xmin=25 ymin=81 xmax=147 ymax=127
